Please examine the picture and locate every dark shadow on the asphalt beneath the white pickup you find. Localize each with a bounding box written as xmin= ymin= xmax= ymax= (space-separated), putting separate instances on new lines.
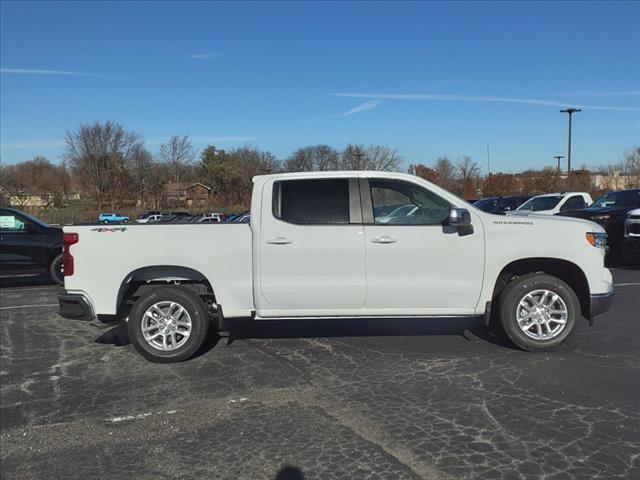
xmin=95 ymin=317 xmax=517 ymax=358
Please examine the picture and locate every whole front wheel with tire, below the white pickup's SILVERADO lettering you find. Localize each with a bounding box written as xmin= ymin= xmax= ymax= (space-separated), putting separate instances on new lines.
xmin=499 ymin=273 xmax=580 ymax=352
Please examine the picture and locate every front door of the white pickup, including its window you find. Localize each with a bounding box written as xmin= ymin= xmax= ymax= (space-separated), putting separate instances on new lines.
xmin=361 ymin=178 xmax=484 ymax=315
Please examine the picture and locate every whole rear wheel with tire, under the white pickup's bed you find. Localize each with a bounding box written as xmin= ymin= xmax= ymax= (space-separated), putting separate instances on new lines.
xmin=127 ymin=286 xmax=209 ymax=363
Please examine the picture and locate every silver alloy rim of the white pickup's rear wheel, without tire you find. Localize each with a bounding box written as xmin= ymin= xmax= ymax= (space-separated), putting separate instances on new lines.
xmin=141 ymin=301 xmax=191 ymax=351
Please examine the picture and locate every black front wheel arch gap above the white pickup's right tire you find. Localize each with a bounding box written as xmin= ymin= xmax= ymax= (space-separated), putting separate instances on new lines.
xmin=491 ymin=257 xmax=591 ymax=319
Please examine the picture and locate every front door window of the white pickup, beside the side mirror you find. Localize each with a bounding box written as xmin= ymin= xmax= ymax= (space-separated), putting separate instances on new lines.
xmin=369 ymin=179 xmax=451 ymax=225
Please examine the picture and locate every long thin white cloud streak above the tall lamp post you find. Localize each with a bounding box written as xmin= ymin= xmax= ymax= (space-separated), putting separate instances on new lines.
xmin=332 ymin=93 xmax=640 ymax=111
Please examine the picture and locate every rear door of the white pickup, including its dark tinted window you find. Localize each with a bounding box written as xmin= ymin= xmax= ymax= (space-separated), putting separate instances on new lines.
xmin=252 ymin=177 xmax=365 ymax=317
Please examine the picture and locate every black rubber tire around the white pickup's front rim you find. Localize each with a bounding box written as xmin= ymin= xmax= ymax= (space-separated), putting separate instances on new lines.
xmin=498 ymin=273 xmax=581 ymax=352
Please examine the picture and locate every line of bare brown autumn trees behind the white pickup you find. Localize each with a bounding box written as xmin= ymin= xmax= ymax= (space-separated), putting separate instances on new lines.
xmin=0 ymin=121 xmax=640 ymax=211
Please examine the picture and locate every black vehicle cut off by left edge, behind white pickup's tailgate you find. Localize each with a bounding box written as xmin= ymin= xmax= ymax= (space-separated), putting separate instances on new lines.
xmin=0 ymin=208 xmax=64 ymax=285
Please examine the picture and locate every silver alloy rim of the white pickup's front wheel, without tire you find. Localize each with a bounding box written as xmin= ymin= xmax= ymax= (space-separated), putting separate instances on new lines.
xmin=516 ymin=290 xmax=569 ymax=340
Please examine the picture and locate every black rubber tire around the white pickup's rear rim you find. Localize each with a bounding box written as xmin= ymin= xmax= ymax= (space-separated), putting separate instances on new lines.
xmin=127 ymin=286 xmax=210 ymax=363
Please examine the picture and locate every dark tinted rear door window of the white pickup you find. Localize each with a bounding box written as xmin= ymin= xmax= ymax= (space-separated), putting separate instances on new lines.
xmin=273 ymin=178 xmax=349 ymax=225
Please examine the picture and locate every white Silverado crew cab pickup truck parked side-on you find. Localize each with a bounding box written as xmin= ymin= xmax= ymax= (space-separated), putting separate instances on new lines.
xmin=59 ymin=172 xmax=613 ymax=362
